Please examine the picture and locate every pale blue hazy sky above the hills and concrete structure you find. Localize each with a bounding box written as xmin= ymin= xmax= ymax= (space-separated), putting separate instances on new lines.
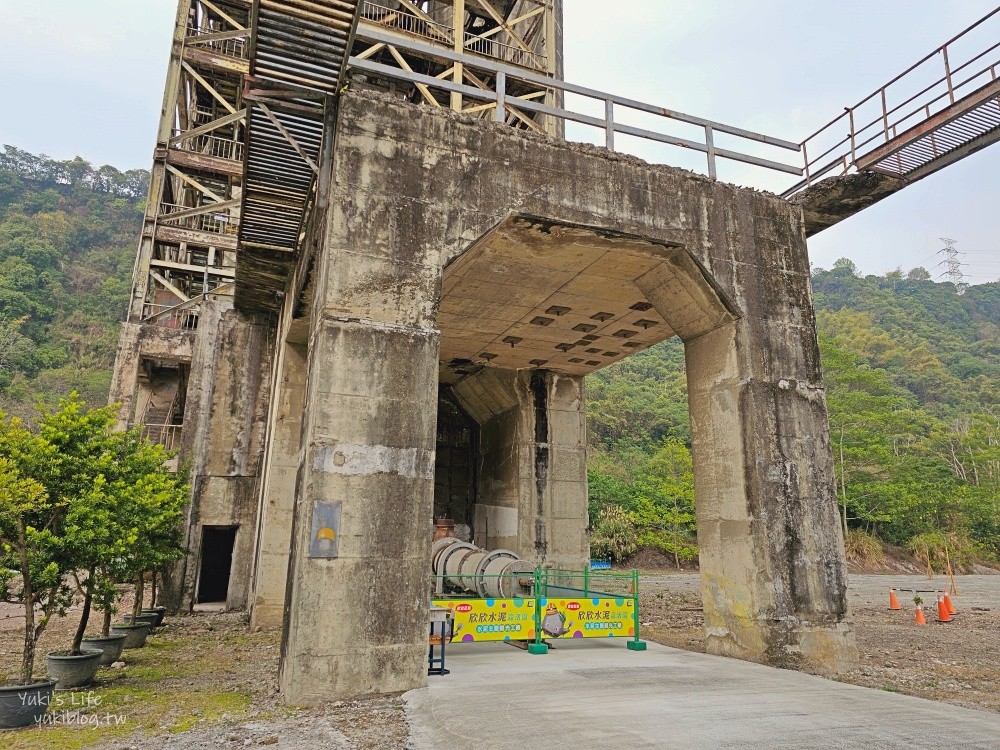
xmin=0 ymin=0 xmax=1000 ymax=282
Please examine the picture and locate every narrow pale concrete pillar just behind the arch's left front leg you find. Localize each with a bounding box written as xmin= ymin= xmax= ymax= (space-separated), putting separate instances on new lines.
xmin=250 ymin=342 xmax=307 ymax=628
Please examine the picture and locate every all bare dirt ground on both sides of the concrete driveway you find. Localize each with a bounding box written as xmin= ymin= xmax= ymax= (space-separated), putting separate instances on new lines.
xmin=0 ymin=570 xmax=1000 ymax=750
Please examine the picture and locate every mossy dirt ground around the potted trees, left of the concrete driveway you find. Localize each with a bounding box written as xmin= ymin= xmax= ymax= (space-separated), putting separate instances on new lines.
xmin=0 ymin=604 xmax=408 ymax=750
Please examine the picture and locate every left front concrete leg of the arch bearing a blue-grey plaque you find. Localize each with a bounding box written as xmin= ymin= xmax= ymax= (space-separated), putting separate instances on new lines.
xmin=280 ymin=225 xmax=440 ymax=705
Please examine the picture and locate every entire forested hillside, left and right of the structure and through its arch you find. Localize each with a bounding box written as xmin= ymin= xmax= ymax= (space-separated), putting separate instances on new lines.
xmin=0 ymin=146 xmax=1000 ymax=561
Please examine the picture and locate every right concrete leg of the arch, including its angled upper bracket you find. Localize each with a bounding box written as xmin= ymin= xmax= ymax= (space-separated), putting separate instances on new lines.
xmin=639 ymin=247 xmax=857 ymax=672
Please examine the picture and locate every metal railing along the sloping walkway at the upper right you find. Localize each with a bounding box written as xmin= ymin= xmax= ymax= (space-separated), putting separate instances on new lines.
xmin=784 ymin=8 xmax=1000 ymax=198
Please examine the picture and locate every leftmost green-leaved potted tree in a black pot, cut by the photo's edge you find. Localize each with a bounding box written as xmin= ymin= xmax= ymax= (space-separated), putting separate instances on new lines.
xmin=0 ymin=434 xmax=64 ymax=729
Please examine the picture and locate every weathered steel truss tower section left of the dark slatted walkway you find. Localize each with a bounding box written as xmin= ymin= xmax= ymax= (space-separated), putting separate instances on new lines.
xmin=128 ymin=0 xmax=250 ymax=327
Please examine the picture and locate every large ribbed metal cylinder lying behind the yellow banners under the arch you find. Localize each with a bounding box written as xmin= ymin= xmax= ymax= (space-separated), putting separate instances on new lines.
xmin=431 ymin=537 xmax=534 ymax=599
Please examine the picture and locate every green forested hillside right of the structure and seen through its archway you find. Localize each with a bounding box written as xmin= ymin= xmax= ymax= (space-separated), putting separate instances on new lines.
xmin=588 ymin=259 xmax=1000 ymax=565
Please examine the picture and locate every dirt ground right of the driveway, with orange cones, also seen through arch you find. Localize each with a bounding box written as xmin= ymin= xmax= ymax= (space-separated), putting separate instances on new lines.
xmin=640 ymin=571 xmax=1000 ymax=712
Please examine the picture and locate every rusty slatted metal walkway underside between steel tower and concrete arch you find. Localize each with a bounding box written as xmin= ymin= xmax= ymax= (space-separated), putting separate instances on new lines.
xmin=236 ymin=0 xmax=360 ymax=311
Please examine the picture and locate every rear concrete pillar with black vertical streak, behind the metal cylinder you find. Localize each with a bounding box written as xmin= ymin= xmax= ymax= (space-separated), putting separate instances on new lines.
xmin=455 ymin=370 xmax=590 ymax=568
